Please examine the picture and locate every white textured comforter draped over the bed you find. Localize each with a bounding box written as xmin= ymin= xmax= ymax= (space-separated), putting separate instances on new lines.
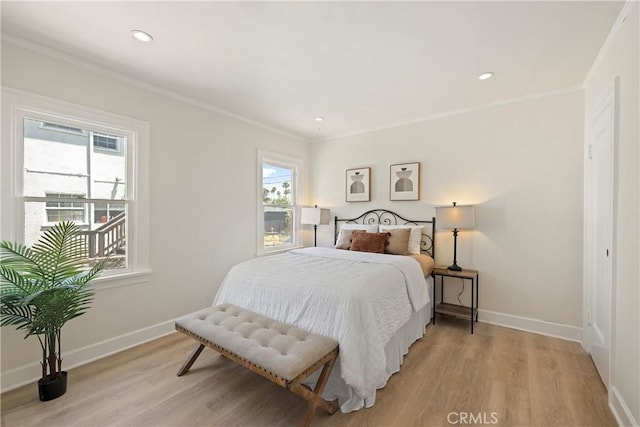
xmin=214 ymin=248 xmax=429 ymax=400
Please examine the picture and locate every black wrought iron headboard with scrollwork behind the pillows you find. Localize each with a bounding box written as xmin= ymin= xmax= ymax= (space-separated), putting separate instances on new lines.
xmin=333 ymin=209 xmax=436 ymax=259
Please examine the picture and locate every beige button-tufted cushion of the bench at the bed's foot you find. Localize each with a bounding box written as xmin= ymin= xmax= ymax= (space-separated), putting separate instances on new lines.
xmin=176 ymin=304 xmax=338 ymax=381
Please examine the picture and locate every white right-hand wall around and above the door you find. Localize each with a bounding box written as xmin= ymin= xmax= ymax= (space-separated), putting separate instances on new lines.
xmin=585 ymin=2 xmax=640 ymax=425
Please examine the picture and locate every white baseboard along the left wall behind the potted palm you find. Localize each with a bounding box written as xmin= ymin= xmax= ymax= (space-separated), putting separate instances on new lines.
xmin=0 ymin=320 xmax=175 ymax=393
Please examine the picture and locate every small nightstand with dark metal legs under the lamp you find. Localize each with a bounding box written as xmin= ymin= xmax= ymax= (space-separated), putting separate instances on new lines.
xmin=433 ymin=265 xmax=480 ymax=333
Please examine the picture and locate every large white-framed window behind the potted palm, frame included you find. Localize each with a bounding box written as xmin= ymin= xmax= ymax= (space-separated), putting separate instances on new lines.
xmin=0 ymin=89 xmax=149 ymax=285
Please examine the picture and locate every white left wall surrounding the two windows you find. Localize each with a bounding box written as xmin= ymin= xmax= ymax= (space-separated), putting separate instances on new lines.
xmin=1 ymin=41 xmax=309 ymax=390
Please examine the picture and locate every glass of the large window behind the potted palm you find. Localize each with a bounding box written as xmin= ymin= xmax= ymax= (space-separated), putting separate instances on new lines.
xmin=23 ymin=118 xmax=129 ymax=269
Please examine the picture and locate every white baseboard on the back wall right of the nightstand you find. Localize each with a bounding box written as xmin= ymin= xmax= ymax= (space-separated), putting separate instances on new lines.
xmin=478 ymin=310 xmax=582 ymax=342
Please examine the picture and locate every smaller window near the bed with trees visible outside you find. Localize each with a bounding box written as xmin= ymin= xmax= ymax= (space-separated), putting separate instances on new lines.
xmin=258 ymin=152 xmax=300 ymax=253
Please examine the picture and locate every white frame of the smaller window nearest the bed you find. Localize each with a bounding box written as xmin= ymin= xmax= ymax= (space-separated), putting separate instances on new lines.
xmin=256 ymin=150 xmax=304 ymax=256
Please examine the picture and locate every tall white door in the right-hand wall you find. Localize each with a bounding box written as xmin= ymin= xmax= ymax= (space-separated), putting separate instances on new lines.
xmin=585 ymin=82 xmax=616 ymax=388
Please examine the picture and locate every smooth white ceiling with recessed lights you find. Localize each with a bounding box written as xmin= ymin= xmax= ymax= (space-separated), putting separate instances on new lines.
xmin=2 ymin=1 xmax=624 ymax=140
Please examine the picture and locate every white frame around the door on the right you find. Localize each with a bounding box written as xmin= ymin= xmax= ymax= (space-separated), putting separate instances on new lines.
xmin=582 ymin=77 xmax=619 ymax=390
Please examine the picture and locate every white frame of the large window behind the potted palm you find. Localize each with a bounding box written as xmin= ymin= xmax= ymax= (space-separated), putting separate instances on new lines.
xmin=0 ymin=87 xmax=151 ymax=289
